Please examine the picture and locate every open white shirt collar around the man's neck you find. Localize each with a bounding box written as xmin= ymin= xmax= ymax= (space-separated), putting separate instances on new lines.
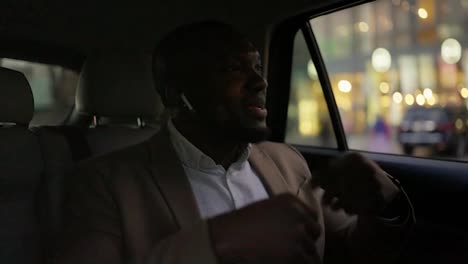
xmin=167 ymin=119 xmax=252 ymax=170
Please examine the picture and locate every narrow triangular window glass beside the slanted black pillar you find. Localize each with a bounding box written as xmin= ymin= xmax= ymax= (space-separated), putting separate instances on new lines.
xmin=286 ymin=31 xmax=337 ymax=148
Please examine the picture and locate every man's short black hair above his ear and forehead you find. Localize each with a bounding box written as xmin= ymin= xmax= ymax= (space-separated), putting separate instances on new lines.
xmin=153 ymin=20 xmax=248 ymax=107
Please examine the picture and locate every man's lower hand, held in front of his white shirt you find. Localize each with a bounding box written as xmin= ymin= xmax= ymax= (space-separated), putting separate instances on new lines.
xmin=209 ymin=194 xmax=321 ymax=264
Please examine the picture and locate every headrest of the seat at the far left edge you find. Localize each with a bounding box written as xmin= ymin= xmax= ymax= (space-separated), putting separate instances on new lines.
xmin=0 ymin=67 xmax=34 ymax=125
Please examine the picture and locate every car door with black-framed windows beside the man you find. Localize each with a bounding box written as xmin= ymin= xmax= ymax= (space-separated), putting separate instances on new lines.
xmin=267 ymin=0 xmax=468 ymax=263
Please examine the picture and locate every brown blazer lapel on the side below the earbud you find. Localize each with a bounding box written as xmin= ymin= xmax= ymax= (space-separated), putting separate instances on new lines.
xmin=145 ymin=126 xmax=201 ymax=229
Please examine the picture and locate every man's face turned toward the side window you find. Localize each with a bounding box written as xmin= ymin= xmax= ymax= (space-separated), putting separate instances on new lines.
xmin=184 ymin=35 xmax=269 ymax=142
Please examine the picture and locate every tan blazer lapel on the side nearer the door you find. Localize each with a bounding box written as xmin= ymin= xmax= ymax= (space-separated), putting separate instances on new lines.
xmin=249 ymin=144 xmax=288 ymax=196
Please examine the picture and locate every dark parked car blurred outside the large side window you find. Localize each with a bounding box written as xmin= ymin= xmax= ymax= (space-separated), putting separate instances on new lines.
xmin=398 ymin=106 xmax=468 ymax=157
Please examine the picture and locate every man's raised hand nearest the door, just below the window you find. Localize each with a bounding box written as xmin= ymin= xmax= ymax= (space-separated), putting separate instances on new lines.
xmin=319 ymin=153 xmax=400 ymax=215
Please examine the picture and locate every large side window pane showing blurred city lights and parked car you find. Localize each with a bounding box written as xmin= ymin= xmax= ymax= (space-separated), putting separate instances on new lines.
xmin=310 ymin=0 xmax=468 ymax=160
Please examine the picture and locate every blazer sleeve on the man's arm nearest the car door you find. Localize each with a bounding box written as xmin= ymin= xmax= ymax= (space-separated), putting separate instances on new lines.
xmin=296 ymin=151 xmax=414 ymax=264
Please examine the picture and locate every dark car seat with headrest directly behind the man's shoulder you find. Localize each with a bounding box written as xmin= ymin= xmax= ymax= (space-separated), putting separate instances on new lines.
xmin=33 ymin=54 xmax=162 ymax=257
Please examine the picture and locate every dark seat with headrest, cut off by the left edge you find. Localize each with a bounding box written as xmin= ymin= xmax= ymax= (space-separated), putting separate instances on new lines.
xmin=0 ymin=68 xmax=43 ymax=264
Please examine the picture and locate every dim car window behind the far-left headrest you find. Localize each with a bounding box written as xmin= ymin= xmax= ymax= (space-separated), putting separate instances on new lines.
xmin=0 ymin=58 xmax=78 ymax=126
